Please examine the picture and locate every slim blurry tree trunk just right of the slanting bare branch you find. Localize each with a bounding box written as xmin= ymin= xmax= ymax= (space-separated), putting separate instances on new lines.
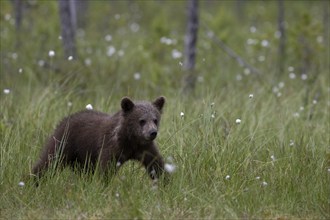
xmin=278 ymin=0 xmax=286 ymax=75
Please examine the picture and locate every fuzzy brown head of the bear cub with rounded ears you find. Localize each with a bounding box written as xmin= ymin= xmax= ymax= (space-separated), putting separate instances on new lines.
xmin=121 ymin=96 xmax=165 ymax=144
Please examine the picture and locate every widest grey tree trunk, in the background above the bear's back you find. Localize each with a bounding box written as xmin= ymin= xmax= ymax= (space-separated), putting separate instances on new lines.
xmin=59 ymin=0 xmax=77 ymax=58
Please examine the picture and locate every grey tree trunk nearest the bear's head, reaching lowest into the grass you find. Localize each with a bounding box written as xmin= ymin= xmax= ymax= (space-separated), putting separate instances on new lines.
xmin=183 ymin=0 xmax=198 ymax=92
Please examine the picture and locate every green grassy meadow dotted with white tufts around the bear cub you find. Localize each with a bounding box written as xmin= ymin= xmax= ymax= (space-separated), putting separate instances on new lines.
xmin=0 ymin=0 xmax=330 ymax=219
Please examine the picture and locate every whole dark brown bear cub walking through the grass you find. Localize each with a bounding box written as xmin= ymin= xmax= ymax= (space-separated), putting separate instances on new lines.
xmin=32 ymin=97 xmax=165 ymax=182
